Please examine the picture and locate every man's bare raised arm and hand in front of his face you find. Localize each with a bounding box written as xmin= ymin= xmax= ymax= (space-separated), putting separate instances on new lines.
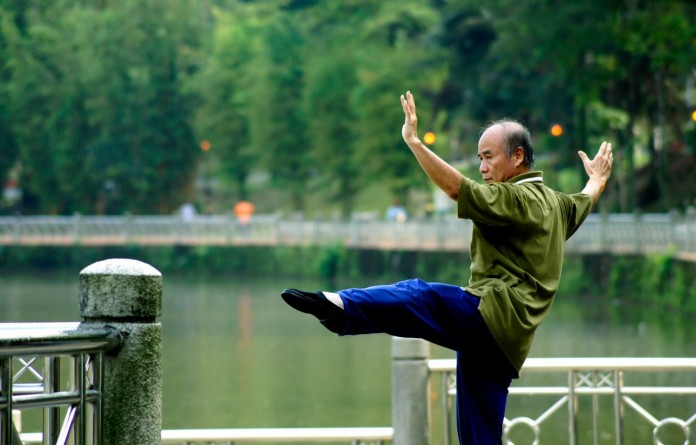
xmin=401 ymin=91 xmax=464 ymax=201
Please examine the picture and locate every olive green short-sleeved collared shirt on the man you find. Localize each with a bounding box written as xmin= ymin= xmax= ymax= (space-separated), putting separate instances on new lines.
xmin=457 ymin=171 xmax=592 ymax=372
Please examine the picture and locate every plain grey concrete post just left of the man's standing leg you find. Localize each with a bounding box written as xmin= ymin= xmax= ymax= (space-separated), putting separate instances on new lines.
xmin=392 ymin=337 xmax=430 ymax=445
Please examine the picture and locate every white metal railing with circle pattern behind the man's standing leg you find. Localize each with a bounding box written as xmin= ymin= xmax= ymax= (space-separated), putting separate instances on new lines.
xmin=428 ymin=358 xmax=696 ymax=445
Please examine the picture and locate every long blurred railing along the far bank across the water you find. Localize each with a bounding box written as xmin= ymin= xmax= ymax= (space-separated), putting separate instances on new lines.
xmin=0 ymin=214 xmax=696 ymax=255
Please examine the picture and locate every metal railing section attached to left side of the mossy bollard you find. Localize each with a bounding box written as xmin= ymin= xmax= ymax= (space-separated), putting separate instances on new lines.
xmin=0 ymin=322 xmax=121 ymax=445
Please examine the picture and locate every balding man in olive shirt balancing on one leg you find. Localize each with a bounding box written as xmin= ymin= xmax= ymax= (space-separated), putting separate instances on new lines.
xmin=281 ymin=92 xmax=612 ymax=445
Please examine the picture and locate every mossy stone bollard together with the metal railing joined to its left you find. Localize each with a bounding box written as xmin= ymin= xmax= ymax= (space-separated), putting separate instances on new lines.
xmin=0 ymin=259 xmax=162 ymax=445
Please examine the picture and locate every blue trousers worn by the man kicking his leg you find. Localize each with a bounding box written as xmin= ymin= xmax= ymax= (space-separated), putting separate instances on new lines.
xmin=338 ymin=279 xmax=517 ymax=445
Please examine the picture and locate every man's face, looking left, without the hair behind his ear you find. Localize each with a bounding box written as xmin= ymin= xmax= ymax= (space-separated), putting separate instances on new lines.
xmin=478 ymin=126 xmax=521 ymax=184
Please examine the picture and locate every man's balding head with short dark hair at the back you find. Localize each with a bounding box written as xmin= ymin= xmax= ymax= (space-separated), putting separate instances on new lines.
xmin=478 ymin=119 xmax=534 ymax=184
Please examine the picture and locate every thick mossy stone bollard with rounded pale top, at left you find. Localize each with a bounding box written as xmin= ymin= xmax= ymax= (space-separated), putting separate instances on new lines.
xmin=80 ymin=259 xmax=162 ymax=445
